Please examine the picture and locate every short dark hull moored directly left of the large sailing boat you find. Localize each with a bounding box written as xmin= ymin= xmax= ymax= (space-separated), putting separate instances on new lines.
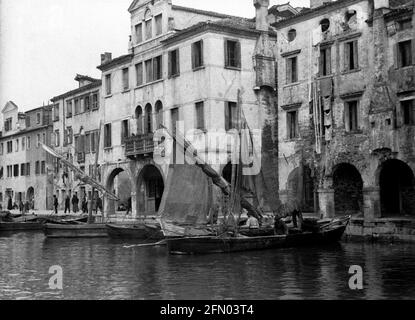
xmin=106 ymin=224 xmax=164 ymax=240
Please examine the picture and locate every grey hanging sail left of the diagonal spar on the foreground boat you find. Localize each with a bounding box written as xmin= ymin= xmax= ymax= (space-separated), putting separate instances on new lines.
xmin=159 ymin=164 xmax=210 ymax=225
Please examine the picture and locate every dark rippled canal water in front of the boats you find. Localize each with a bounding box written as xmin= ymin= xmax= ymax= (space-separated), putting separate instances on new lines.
xmin=0 ymin=233 xmax=415 ymax=300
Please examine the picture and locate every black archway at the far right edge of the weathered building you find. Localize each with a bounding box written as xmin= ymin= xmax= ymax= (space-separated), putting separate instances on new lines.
xmin=379 ymin=160 xmax=415 ymax=217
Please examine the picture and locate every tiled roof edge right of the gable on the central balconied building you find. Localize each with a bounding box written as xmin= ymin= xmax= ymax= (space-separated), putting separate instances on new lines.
xmin=162 ymin=18 xmax=276 ymax=44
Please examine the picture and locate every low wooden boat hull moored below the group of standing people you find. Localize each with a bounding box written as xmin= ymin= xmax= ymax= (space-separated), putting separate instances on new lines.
xmin=43 ymin=223 xmax=108 ymax=238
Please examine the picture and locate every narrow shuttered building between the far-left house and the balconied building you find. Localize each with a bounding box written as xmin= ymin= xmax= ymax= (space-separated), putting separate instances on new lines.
xmin=51 ymin=74 xmax=101 ymax=210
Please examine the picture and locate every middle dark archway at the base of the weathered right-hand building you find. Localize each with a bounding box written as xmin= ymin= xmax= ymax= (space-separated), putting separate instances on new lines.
xmin=333 ymin=163 xmax=363 ymax=215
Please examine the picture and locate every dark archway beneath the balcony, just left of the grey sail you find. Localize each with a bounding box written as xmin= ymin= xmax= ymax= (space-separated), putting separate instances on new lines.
xmin=137 ymin=165 xmax=164 ymax=216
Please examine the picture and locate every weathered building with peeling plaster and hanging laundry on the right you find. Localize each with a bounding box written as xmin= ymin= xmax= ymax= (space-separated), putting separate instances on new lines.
xmin=273 ymin=0 xmax=415 ymax=238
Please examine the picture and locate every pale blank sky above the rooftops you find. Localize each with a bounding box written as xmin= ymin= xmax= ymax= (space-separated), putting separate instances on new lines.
xmin=0 ymin=0 xmax=309 ymax=111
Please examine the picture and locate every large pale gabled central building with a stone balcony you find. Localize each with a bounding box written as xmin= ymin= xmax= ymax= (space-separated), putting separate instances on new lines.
xmin=98 ymin=0 xmax=286 ymax=216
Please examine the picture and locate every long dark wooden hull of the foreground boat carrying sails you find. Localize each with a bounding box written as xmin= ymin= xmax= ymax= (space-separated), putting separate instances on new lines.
xmin=167 ymin=225 xmax=346 ymax=254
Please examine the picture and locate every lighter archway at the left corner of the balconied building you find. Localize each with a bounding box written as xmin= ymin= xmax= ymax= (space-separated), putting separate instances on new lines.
xmin=105 ymin=168 xmax=131 ymax=215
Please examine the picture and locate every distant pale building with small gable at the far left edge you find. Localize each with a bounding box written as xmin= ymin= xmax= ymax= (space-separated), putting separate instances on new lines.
xmin=0 ymin=101 xmax=52 ymax=210
